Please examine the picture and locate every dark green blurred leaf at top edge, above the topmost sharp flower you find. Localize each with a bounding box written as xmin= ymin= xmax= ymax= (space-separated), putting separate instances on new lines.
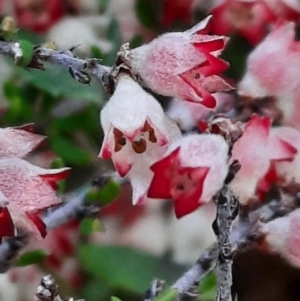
xmin=135 ymin=0 xmax=162 ymax=31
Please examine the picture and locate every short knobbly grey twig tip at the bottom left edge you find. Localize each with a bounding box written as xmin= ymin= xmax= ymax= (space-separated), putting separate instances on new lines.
xmin=35 ymin=275 xmax=84 ymax=301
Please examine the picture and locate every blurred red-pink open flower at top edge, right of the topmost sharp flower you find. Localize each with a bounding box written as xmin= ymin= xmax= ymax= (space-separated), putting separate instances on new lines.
xmin=211 ymin=0 xmax=276 ymax=44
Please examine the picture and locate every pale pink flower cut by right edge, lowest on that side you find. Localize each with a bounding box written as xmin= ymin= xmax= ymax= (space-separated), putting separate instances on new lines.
xmin=261 ymin=209 xmax=300 ymax=268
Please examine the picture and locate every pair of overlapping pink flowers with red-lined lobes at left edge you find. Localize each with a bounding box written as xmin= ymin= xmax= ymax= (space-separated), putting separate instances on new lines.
xmin=0 ymin=124 xmax=70 ymax=239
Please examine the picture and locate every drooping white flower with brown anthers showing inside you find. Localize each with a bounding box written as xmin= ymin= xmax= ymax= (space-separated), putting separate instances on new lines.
xmin=99 ymin=74 xmax=181 ymax=204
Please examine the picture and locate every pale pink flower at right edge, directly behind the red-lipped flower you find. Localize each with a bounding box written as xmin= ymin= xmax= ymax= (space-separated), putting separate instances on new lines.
xmin=271 ymin=127 xmax=300 ymax=185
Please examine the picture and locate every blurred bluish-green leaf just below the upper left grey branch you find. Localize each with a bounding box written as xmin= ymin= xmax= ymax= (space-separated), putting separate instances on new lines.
xmin=17 ymin=65 xmax=103 ymax=103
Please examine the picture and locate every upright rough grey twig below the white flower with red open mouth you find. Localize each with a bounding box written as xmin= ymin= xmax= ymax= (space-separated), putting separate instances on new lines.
xmin=215 ymin=185 xmax=238 ymax=301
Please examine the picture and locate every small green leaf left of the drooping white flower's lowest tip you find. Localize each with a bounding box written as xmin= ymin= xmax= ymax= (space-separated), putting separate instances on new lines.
xmin=87 ymin=181 xmax=120 ymax=205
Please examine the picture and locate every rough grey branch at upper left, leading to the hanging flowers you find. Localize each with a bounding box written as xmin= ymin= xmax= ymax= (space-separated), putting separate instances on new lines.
xmin=0 ymin=41 xmax=111 ymax=89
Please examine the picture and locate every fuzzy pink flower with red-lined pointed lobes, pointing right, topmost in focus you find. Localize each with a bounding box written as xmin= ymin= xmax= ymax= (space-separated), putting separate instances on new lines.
xmin=125 ymin=16 xmax=232 ymax=108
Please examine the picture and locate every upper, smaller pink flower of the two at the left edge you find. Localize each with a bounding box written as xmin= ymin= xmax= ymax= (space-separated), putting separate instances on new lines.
xmin=0 ymin=124 xmax=46 ymax=158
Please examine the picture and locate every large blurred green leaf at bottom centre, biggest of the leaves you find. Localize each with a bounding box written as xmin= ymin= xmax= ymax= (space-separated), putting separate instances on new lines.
xmin=79 ymin=245 xmax=184 ymax=293
